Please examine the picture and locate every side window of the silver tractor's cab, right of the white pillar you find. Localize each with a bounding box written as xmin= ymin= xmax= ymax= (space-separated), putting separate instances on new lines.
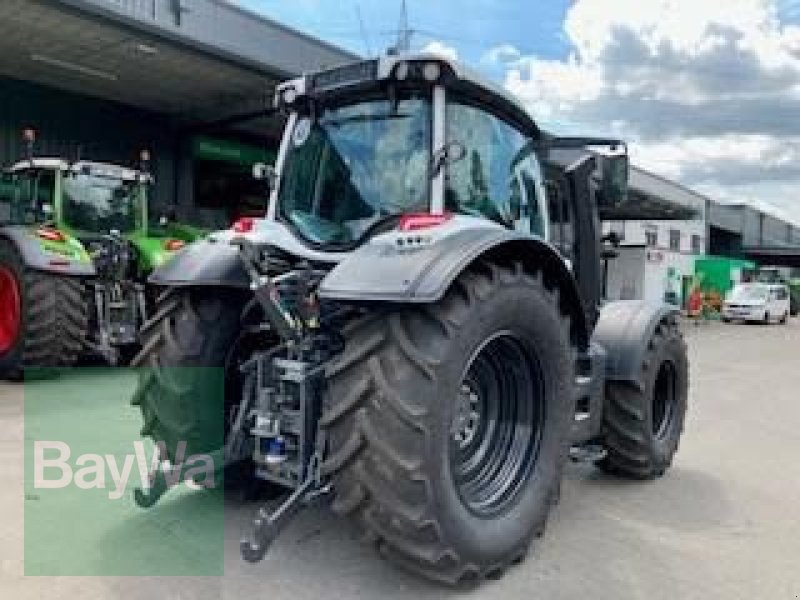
xmin=445 ymin=101 xmax=548 ymax=237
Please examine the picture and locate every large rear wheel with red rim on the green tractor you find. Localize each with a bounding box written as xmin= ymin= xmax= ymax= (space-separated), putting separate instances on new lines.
xmin=0 ymin=240 xmax=88 ymax=378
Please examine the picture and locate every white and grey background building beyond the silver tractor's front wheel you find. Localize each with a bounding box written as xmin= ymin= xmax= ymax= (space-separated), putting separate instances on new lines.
xmin=605 ymin=167 xmax=800 ymax=305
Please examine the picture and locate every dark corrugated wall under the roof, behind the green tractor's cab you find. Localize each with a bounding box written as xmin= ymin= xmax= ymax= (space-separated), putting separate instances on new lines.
xmin=0 ymin=78 xmax=177 ymax=211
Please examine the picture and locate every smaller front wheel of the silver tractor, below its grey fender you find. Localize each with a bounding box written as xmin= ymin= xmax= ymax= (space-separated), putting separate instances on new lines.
xmin=597 ymin=319 xmax=689 ymax=479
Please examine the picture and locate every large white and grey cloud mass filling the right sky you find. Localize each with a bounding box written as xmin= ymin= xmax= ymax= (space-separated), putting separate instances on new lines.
xmin=504 ymin=0 xmax=800 ymax=220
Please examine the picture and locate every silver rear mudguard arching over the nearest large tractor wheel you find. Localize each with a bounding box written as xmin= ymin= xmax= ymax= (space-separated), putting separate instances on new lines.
xmin=319 ymin=223 xmax=588 ymax=348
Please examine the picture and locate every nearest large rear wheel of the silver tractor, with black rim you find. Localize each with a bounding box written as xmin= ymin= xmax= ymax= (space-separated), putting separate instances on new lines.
xmin=321 ymin=264 xmax=575 ymax=584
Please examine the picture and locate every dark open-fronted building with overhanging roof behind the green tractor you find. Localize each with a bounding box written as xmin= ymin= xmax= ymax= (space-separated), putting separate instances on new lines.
xmin=0 ymin=0 xmax=354 ymax=227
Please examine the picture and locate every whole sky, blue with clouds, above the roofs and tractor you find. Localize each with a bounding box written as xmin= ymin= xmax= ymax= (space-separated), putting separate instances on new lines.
xmin=238 ymin=0 xmax=800 ymax=224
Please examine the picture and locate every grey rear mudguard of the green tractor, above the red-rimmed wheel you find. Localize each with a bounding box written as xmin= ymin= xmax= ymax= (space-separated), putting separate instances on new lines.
xmin=0 ymin=225 xmax=96 ymax=277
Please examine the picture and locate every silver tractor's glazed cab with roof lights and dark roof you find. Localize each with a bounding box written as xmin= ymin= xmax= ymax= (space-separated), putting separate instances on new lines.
xmin=260 ymin=55 xmax=627 ymax=251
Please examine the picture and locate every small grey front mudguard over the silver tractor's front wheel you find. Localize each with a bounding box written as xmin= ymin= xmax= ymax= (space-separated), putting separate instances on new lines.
xmin=592 ymin=300 xmax=679 ymax=383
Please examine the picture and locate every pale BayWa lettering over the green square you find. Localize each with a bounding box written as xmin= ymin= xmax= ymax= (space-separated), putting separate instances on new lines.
xmin=33 ymin=441 xmax=215 ymax=500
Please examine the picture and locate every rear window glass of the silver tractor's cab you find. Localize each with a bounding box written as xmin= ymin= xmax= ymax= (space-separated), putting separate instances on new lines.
xmin=278 ymin=96 xmax=431 ymax=245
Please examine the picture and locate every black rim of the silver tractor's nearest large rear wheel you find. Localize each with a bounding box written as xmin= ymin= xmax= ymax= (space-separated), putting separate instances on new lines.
xmin=450 ymin=332 xmax=544 ymax=517
